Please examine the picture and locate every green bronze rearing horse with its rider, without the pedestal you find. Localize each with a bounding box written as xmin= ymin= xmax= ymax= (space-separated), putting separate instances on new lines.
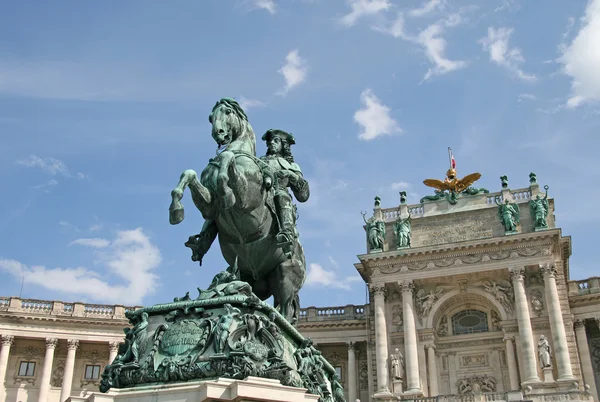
xmin=169 ymin=98 xmax=310 ymax=323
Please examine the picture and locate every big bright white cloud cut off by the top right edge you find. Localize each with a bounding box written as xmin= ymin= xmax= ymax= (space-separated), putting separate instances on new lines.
xmin=558 ymin=0 xmax=600 ymax=108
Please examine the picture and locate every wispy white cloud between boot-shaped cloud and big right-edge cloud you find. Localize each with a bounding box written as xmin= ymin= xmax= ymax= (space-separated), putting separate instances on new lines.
xmin=477 ymin=27 xmax=537 ymax=82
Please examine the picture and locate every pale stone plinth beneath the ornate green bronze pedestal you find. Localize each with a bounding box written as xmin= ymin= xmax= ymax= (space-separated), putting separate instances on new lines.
xmin=67 ymin=377 xmax=319 ymax=402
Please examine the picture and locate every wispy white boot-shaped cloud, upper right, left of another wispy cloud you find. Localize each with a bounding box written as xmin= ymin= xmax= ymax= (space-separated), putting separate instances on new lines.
xmin=418 ymin=23 xmax=467 ymax=81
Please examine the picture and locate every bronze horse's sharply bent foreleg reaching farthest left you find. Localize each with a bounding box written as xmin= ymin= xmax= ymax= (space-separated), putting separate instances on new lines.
xmin=169 ymin=169 xmax=215 ymax=225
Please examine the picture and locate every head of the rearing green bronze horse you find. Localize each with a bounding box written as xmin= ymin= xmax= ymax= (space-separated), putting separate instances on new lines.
xmin=208 ymin=98 xmax=256 ymax=155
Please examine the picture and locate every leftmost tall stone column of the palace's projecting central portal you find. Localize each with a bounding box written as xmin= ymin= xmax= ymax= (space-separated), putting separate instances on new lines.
xmin=371 ymin=285 xmax=390 ymax=394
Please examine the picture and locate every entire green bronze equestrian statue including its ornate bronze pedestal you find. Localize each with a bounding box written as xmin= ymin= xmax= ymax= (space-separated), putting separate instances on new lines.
xmin=100 ymin=98 xmax=345 ymax=402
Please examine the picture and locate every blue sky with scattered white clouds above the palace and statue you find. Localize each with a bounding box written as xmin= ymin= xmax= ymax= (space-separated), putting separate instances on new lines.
xmin=0 ymin=0 xmax=600 ymax=306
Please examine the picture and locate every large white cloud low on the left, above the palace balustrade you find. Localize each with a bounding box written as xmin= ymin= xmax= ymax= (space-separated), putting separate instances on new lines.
xmin=0 ymin=228 xmax=161 ymax=305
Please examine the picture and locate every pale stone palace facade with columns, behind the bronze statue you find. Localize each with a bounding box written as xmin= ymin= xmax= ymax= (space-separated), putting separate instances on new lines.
xmin=0 ymin=176 xmax=600 ymax=402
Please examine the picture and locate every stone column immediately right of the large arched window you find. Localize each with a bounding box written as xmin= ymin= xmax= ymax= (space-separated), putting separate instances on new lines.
xmin=510 ymin=268 xmax=540 ymax=383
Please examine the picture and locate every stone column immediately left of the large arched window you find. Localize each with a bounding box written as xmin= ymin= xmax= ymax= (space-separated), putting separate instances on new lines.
xmin=401 ymin=281 xmax=422 ymax=394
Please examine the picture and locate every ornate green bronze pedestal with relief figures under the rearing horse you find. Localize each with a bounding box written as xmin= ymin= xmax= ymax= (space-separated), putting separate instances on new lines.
xmin=100 ymin=267 xmax=344 ymax=402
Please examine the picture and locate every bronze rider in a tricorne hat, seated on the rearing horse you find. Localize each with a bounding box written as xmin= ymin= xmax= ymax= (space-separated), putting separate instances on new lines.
xmin=261 ymin=129 xmax=308 ymax=258
